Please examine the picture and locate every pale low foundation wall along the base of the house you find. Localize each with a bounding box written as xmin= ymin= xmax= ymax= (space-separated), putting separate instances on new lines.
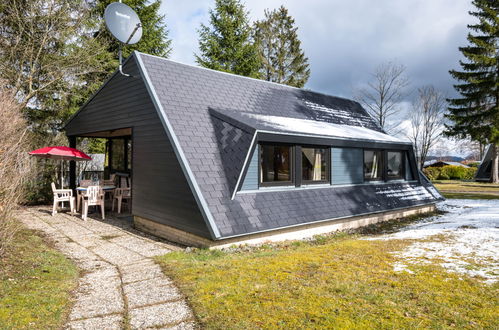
xmin=134 ymin=204 xmax=435 ymax=248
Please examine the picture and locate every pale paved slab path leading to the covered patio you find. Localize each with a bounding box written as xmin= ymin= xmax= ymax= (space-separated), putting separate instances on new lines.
xmin=19 ymin=207 xmax=199 ymax=330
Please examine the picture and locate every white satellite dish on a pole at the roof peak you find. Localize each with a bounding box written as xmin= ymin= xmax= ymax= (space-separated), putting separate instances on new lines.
xmin=104 ymin=2 xmax=142 ymax=76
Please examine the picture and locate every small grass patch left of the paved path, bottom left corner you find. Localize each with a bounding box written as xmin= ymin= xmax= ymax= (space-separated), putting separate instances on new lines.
xmin=0 ymin=230 xmax=79 ymax=329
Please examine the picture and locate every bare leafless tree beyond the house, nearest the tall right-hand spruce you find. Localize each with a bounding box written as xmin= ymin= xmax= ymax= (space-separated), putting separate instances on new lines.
xmin=408 ymin=86 xmax=447 ymax=169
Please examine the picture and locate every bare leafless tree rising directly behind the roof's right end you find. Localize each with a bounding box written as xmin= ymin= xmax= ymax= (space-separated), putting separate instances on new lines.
xmin=355 ymin=62 xmax=409 ymax=133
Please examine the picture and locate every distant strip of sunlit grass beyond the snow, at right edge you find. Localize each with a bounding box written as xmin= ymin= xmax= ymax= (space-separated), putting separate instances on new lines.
xmin=433 ymin=180 xmax=499 ymax=199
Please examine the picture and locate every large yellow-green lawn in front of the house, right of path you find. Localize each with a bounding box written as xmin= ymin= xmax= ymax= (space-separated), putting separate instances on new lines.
xmin=157 ymin=234 xmax=499 ymax=329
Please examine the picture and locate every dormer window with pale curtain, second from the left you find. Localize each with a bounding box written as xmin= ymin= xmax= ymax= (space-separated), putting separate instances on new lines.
xmin=301 ymin=147 xmax=330 ymax=183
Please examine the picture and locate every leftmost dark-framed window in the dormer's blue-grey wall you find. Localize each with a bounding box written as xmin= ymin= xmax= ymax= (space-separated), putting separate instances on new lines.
xmin=260 ymin=144 xmax=293 ymax=186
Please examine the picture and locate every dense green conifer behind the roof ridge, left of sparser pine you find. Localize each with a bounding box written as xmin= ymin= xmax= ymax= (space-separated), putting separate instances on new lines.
xmin=196 ymin=0 xmax=260 ymax=78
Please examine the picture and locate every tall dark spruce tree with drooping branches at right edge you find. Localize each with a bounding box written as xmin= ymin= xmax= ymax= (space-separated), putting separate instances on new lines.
xmin=446 ymin=0 xmax=499 ymax=183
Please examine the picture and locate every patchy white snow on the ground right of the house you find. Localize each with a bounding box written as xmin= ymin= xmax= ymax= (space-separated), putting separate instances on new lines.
xmin=374 ymin=199 xmax=499 ymax=283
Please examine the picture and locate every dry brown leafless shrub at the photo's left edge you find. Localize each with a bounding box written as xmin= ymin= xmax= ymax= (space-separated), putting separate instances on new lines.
xmin=0 ymin=81 xmax=31 ymax=256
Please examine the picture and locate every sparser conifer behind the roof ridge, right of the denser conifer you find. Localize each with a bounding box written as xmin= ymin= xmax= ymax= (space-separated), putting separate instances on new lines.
xmin=254 ymin=6 xmax=310 ymax=87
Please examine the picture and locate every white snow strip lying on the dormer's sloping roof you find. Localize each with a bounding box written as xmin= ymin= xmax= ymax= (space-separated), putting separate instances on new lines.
xmin=243 ymin=113 xmax=407 ymax=143
